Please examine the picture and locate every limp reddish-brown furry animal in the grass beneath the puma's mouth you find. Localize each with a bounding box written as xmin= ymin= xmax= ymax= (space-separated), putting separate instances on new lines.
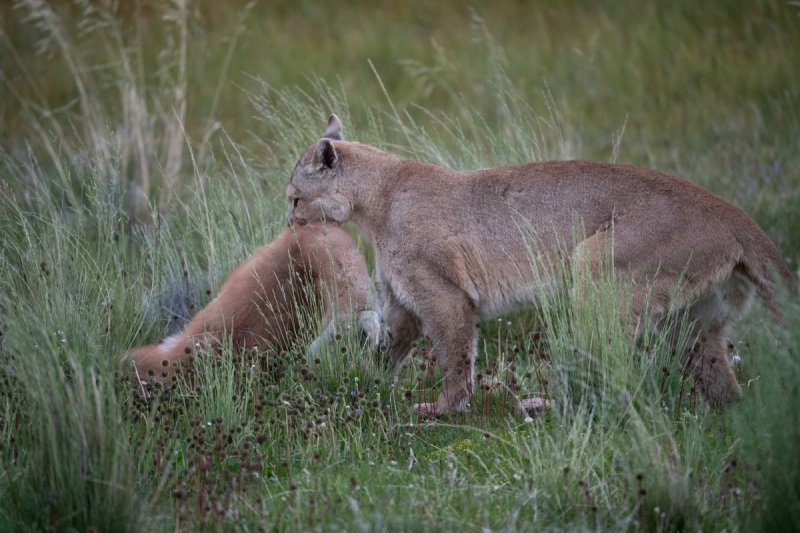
xmin=126 ymin=222 xmax=381 ymax=381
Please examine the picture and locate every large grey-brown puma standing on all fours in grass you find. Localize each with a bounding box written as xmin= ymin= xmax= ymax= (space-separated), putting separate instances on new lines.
xmin=287 ymin=115 xmax=792 ymax=414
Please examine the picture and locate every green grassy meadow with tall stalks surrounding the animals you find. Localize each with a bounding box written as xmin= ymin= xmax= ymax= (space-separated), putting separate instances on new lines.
xmin=0 ymin=0 xmax=800 ymax=531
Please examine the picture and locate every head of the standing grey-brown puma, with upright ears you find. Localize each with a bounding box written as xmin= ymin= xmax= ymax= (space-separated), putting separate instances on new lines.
xmin=286 ymin=115 xmax=353 ymax=224
